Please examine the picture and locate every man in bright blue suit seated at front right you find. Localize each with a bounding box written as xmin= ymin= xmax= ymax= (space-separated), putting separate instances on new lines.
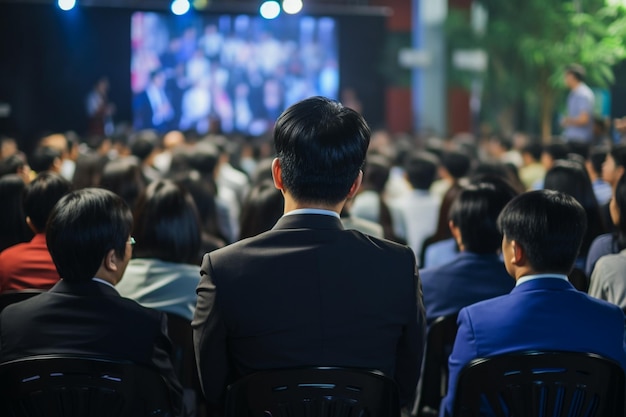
xmin=440 ymin=190 xmax=626 ymax=416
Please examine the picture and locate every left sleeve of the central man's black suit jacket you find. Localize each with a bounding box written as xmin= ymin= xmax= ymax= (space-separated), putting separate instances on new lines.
xmin=191 ymin=254 xmax=230 ymax=407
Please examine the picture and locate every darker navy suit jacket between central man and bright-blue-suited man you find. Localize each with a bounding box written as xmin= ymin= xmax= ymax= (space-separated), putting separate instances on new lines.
xmin=420 ymin=252 xmax=515 ymax=323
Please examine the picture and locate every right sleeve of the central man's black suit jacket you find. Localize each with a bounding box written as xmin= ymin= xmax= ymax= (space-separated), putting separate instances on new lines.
xmin=395 ymin=248 xmax=426 ymax=406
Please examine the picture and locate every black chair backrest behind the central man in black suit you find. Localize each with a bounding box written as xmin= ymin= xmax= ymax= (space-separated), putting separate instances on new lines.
xmin=225 ymin=367 xmax=400 ymax=417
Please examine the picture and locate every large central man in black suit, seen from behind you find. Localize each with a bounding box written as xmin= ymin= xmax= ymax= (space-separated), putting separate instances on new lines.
xmin=192 ymin=97 xmax=425 ymax=407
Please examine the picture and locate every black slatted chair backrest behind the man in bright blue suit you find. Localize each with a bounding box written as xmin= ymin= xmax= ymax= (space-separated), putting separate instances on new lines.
xmin=454 ymin=352 xmax=624 ymax=417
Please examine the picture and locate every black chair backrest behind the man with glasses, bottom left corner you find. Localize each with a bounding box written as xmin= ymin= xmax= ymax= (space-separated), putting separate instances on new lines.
xmin=0 ymin=355 xmax=173 ymax=417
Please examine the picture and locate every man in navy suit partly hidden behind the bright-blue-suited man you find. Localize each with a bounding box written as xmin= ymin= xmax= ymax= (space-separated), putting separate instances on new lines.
xmin=420 ymin=178 xmax=516 ymax=324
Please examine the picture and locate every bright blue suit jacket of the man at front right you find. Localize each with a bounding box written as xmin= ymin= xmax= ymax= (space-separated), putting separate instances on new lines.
xmin=440 ymin=278 xmax=626 ymax=416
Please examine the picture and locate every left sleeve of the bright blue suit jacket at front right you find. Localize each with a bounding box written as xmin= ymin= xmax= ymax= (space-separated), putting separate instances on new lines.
xmin=439 ymin=308 xmax=478 ymax=417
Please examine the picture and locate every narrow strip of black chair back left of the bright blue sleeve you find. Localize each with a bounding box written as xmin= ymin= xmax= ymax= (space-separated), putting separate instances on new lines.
xmin=415 ymin=313 xmax=458 ymax=415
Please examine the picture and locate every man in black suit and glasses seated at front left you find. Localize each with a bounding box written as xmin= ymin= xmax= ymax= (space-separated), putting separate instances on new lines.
xmin=0 ymin=188 xmax=182 ymax=415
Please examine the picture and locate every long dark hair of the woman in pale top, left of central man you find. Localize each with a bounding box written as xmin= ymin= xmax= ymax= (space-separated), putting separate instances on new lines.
xmin=133 ymin=180 xmax=202 ymax=264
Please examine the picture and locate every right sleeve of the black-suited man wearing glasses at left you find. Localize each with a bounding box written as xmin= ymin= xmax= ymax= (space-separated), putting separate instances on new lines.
xmin=152 ymin=313 xmax=183 ymax=416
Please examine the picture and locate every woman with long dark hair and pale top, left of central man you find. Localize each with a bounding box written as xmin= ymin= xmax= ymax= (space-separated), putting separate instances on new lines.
xmin=117 ymin=180 xmax=201 ymax=321
